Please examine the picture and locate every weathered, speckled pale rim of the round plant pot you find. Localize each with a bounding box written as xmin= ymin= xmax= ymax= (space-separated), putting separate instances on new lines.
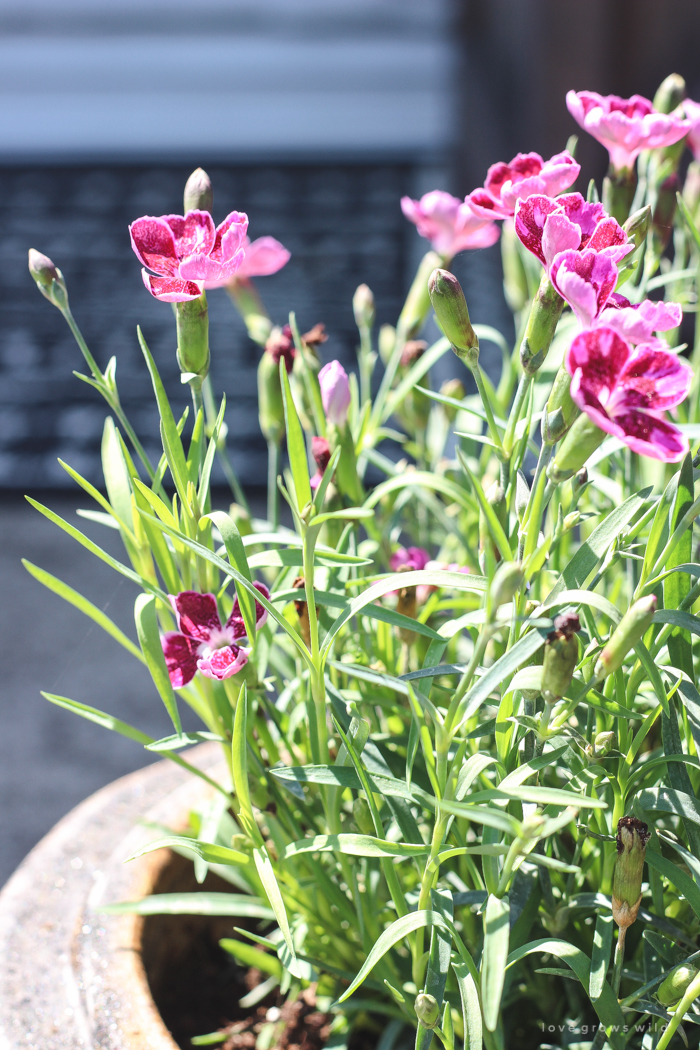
xmin=0 ymin=744 xmax=224 ymax=1050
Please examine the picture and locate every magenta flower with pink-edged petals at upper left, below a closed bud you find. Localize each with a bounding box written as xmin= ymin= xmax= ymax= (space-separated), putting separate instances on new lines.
xmin=129 ymin=211 xmax=248 ymax=302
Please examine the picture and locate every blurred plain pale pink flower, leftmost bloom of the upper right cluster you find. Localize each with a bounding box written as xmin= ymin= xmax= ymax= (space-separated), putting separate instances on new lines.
xmin=401 ymin=190 xmax=501 ymax=259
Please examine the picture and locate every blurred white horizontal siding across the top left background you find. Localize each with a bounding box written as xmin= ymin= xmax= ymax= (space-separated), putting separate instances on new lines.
xmin=0 ymin=0 xmax=452 ymax=161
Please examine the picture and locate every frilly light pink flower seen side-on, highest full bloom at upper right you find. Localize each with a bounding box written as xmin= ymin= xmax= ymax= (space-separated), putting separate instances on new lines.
xmin=567 ymin=91 xmax=691 ymax=171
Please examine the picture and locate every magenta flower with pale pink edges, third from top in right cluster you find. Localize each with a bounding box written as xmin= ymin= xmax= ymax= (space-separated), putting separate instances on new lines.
xmin=515 ymin=193 xmax=634 ymax=274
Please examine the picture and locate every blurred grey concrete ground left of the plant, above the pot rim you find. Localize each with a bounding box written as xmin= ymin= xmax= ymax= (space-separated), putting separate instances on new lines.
xmin=0 ymin=494 xmax=265 ymax=885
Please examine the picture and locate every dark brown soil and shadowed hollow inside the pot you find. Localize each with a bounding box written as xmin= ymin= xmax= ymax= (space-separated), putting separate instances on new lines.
xmin=142 ymin=854 xmax=384 ymax=1050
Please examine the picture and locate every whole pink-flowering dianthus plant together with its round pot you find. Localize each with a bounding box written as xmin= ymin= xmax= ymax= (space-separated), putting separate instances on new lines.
xmin=0 ymin=77 xmax=700 ymax=1050
